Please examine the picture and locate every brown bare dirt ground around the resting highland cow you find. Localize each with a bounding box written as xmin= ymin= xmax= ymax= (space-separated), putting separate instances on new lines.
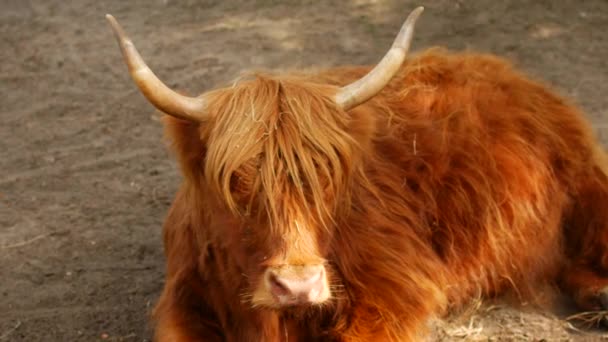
xmin=0 ymin=0 xmax=608 ymax=341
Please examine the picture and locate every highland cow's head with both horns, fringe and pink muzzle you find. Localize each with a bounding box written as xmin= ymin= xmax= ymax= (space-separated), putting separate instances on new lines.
xmin=107 ymin=8 xmax=422 ymax=308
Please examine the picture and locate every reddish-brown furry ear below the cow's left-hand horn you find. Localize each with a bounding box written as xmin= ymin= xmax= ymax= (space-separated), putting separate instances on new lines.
xmin=162 ymin=115 xmax=206 ymax=178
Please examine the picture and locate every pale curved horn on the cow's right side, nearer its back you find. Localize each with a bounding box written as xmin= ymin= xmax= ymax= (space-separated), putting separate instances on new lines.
xmin=335 ymin=6 xmax=424 ymax=110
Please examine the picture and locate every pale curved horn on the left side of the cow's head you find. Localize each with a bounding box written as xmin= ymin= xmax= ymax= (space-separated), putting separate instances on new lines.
xmin=106 ymin=14 xmax=207 ymax=121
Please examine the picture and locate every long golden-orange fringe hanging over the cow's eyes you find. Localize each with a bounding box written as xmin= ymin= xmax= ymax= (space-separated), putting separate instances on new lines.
xmin=204 ymin=74 xmax=357 ymax=226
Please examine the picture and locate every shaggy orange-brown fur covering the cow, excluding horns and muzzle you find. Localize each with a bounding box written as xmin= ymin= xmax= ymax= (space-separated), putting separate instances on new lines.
xmin=150 ymin=49 xmax=608 ymax=341
